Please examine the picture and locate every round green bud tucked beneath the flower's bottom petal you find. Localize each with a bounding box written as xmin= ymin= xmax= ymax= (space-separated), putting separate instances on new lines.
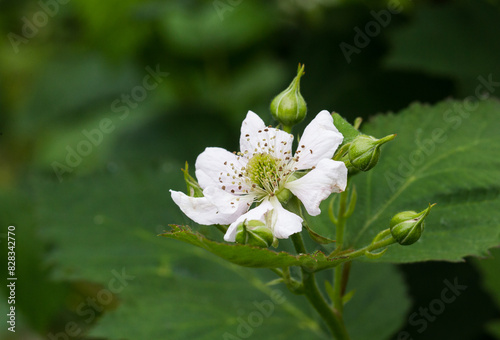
xmin=236 ymin=220 xmax=277 ymax=248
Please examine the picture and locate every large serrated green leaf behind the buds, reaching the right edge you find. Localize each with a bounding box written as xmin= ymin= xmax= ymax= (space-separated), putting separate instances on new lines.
xmin=309 ymin=99 xmax=500 ymax=262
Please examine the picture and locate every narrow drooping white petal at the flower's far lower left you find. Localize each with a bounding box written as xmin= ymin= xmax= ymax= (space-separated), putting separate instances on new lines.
xmin=170 ymin=190 xmax=243 ymax=225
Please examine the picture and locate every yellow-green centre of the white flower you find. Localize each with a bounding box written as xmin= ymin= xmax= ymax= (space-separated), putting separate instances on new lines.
xmin=246 ymin=153 xmax=290 ymax=196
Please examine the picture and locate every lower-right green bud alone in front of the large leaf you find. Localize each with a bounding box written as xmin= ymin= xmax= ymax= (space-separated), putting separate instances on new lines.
xmin=389 ymin=204 xmax=435 ymax=246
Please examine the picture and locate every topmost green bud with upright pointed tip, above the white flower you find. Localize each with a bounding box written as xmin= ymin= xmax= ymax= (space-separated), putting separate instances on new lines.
xmin=271 ymin=64 xmax=307 ymax=130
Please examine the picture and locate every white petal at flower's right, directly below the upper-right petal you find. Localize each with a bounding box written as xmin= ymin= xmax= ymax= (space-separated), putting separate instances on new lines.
xmin=285 ymin=159 xmax=347 ymax=216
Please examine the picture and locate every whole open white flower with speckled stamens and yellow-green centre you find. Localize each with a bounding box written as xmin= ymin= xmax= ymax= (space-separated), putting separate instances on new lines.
xmin=171 ymin=110 xmax=347 ymax=242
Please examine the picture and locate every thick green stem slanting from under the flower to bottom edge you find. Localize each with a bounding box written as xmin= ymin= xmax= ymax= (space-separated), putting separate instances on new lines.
xmin=292 ymin=233 xmax=349 ymax=340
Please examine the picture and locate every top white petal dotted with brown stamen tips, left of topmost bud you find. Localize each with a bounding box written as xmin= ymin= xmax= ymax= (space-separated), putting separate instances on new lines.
xmin=240 ymin=111 xmax=293 ymax=160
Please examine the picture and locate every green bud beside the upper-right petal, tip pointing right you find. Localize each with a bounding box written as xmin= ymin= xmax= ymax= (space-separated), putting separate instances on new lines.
xmin=349 ymin=135 xmax=396 ymax=171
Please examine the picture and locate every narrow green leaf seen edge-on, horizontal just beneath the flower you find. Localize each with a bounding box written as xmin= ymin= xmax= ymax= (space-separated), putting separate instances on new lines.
xmin=161 ymin=225 xmax=346 ymax=271
